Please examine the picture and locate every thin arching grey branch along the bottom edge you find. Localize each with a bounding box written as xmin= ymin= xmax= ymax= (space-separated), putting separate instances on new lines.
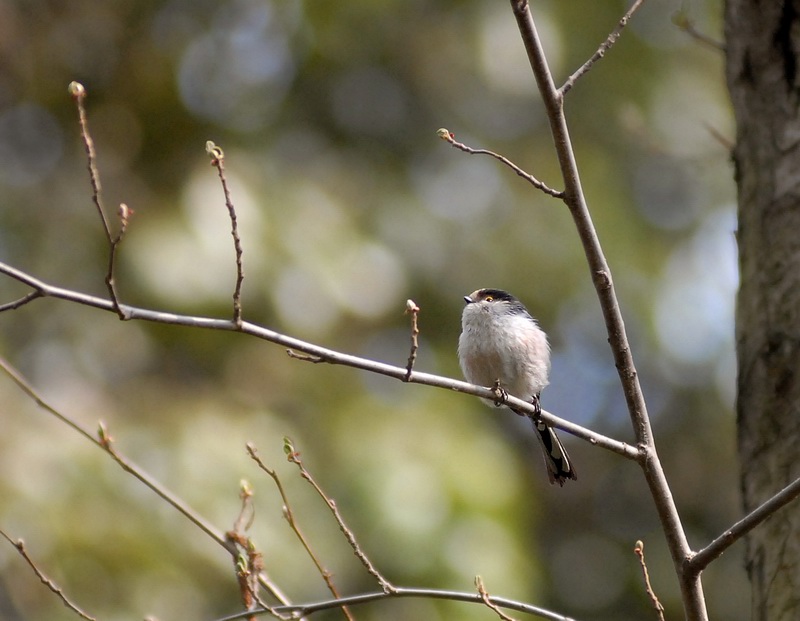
xmin=216 ymin=587 xmax=575 ymax=621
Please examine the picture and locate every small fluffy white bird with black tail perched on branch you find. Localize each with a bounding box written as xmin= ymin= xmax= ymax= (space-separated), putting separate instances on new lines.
xmin=458 ymin=289 xmax=578 ymax=485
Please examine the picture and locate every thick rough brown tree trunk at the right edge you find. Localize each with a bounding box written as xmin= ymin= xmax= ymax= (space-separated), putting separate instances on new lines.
xmin=724 ymin=0 xmax=800 ymax=621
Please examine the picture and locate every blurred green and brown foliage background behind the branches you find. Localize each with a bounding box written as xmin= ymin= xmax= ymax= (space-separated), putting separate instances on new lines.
xmin=0 ymin=0 xmax=749 ymax=621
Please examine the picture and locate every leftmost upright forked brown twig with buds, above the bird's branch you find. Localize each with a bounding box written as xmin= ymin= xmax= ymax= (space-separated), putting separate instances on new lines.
xmin=67 ymin=82 xmax=132 ymax=320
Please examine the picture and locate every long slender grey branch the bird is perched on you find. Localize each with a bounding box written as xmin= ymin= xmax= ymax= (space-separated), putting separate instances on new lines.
xmin=0 ymin=262 xmax=644 ymax=461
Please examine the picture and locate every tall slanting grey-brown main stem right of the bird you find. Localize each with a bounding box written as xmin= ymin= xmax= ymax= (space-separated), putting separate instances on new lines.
xmin=511 ymin=0 xmax=708 ymax=620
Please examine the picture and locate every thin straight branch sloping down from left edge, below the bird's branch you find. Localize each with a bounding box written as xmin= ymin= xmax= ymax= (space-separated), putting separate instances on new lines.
xmin=0 ymin=354 xmax=289 ymax=604
